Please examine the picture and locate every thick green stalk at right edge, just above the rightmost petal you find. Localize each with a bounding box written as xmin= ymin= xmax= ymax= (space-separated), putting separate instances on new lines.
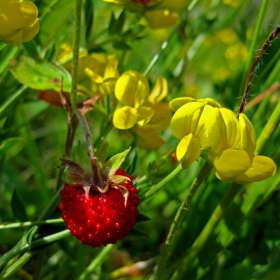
xmin=256 ymin=102 xmax=280 ymax=153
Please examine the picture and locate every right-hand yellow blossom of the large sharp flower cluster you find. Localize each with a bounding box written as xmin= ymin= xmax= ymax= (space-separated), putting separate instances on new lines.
xmin=208 ymin=108 xmax=276 ymax=184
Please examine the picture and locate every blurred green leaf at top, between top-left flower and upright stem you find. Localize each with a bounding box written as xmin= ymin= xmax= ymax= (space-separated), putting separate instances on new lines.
xmin=38 ymin=0 xmax=75 ymax=47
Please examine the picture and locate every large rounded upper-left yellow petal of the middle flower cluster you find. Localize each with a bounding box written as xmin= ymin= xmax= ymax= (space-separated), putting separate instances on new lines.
xmin=115 ymin=70 xmax=149 ymax=108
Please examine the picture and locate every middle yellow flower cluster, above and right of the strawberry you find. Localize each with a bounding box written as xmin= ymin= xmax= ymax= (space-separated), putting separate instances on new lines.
xmin=113 ymin=70 xmax=171 ymax=150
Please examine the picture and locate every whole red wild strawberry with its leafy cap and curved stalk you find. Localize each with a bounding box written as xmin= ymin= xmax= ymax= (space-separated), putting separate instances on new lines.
xmin=59 ymin=110 xmax=139 ymax=247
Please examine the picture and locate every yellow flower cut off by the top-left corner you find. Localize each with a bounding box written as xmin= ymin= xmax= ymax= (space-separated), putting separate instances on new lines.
xmin=0 ymin=0 xmax=40 ymax=46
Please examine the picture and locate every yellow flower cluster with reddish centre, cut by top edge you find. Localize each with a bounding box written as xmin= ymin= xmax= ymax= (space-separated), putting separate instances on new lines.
xmin=104 ymin=0 xmax=189 ymax=29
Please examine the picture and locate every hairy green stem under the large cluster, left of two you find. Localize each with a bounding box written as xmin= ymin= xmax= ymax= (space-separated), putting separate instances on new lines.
xmin=157 ymin=162 xmax=212 ymax=279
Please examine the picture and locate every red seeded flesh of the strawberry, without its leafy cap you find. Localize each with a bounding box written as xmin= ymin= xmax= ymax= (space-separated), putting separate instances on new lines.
xmin=59 ymin=170 xmax=139 ymax=247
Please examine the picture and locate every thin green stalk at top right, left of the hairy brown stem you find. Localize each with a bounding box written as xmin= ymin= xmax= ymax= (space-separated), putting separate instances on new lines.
xmin=240 ymin=0 xmax=268 ymax=100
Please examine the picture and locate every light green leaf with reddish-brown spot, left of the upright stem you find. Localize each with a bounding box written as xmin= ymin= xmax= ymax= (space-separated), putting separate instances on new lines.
xmin=11 ymin=56 xmax=71 ymax=92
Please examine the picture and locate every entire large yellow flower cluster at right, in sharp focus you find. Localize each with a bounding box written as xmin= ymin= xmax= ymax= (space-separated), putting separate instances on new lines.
xmin=170 ymin=98 xmax=276 ymax=184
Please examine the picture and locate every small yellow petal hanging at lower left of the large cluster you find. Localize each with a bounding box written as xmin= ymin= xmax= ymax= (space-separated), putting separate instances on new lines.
xmin=176 ymin=133 xmax=201 ymax=169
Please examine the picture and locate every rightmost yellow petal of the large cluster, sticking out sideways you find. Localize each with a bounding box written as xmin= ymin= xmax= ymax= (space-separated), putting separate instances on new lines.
xmin=234 ymin=155 xmax=276 ymax=184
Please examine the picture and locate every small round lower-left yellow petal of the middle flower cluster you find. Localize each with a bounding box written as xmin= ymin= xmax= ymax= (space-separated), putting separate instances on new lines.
xmin=113 ymin=106 xmax=138 ymax=129
